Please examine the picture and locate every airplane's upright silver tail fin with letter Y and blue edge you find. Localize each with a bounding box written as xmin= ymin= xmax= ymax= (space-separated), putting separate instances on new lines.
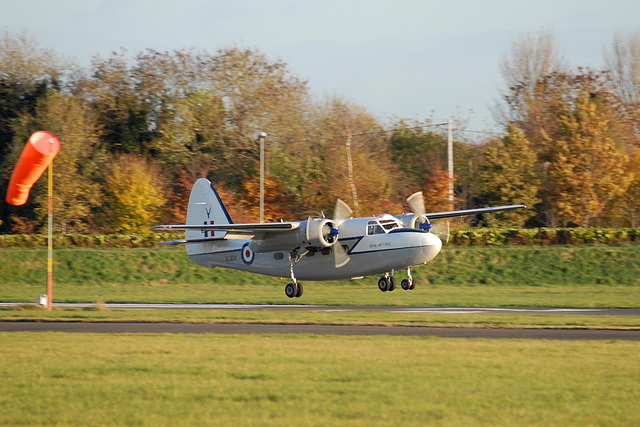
xmin=185 ymin=178 xmax=233 ymax=240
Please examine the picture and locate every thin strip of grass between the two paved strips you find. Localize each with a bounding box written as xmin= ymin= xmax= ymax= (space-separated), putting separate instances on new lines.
xmin=0 ymin=307 xmax=640 ymax=329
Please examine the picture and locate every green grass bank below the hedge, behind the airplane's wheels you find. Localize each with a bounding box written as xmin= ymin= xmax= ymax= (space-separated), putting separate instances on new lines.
xmin=0 ymin=245 xmax=640 ymax=307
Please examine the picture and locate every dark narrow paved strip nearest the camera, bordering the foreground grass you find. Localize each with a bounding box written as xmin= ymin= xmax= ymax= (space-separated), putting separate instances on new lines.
xmin=0 ymin=322 xmax=640 ymax=341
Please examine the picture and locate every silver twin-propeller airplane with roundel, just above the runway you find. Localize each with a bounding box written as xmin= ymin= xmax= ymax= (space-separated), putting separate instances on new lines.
xmin=151 ymin=178 xmax=526 ymax=298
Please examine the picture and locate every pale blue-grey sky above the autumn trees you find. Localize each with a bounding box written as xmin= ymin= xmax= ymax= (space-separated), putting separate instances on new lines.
xmin=0 ymin=0 xmax=640 ymax=130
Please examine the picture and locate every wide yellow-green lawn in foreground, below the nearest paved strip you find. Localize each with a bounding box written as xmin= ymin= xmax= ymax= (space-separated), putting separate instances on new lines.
xmin=0 ymin=333 xmax=640 ymax=426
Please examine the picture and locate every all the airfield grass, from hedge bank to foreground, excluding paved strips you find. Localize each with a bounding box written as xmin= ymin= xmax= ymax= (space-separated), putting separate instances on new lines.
xmin=0 ymin=245 xmax=640 ymax=426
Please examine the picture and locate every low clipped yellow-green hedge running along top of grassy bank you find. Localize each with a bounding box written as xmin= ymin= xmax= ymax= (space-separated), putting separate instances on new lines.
xmin=0 ymin=228 xmax=640 ymax=248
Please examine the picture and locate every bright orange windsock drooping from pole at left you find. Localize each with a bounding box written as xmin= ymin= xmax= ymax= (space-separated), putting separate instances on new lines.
xmin=7 ymin=130 xmax=60 ymax=206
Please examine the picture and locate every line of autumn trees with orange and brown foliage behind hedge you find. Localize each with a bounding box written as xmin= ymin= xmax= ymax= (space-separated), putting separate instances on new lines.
xmin=0 ymin=30 xmax=640 ymax=233
